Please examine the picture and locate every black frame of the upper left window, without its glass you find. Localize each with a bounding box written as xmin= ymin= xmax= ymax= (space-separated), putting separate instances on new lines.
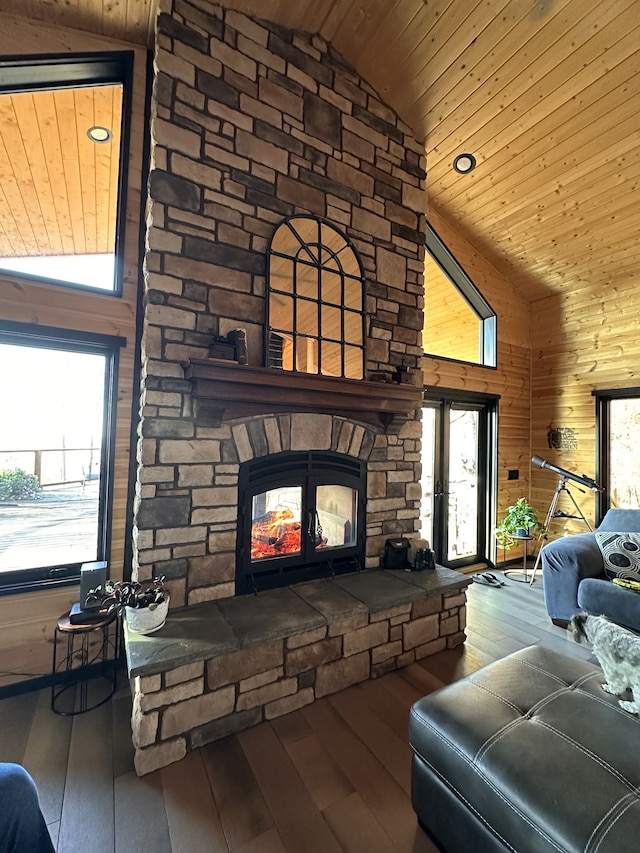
xmin=0 ymin=50 xmax=135 ymax=297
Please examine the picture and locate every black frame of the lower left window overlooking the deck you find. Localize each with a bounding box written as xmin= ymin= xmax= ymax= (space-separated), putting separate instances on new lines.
xmin=0 ymin=320 xmax=126 ymax=596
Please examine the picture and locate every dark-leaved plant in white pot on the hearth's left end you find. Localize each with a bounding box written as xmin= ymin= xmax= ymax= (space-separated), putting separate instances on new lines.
xmin=85 ymin=577 xmax=169 ymax=634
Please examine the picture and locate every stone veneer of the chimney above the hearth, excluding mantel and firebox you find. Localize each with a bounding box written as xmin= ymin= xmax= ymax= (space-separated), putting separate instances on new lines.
xmin=134 ymin=0 xmax=426 ymax=606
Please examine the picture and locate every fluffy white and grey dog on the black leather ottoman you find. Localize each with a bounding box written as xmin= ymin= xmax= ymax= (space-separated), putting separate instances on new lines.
xmin=569 ymin=613 xmax=640 ymax=714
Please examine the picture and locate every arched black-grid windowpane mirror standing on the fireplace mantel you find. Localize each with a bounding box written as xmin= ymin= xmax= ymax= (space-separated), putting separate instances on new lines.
xmin=266 ymin=216 xmax=365 ymax=379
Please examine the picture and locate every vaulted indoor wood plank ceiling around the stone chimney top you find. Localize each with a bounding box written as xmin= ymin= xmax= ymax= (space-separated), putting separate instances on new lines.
xmin=0 ymin=0 xmax=640 ymax=300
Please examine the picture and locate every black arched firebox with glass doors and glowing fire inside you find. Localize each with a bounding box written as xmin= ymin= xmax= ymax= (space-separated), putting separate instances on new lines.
xmin=236 ymin=451 xmax=366 ymax=595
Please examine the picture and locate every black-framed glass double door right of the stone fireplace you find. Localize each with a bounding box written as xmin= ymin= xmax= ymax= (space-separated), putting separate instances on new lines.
xmin=421 ymin=398 xmax=496 ymax=568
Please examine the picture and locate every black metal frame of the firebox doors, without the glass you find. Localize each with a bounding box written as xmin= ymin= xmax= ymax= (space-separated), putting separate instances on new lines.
xmin=235 ymin=450 xmax=367 ymax=595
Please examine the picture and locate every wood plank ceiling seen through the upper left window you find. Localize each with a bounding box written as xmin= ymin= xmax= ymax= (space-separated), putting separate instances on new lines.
xmin=0 ymin=85 xmax=122 ymax=258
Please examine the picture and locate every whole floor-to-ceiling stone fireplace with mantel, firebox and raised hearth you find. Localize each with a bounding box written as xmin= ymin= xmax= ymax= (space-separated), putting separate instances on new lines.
xmin=120 ymin=0 xmax=476 ymax=774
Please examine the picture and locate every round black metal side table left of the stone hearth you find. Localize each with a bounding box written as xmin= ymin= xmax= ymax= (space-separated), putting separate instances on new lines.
xmin=51 ymin=611 xmax=120 ymax=717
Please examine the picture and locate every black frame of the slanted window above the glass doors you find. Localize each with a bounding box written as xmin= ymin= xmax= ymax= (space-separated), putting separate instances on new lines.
xmin=425 ymin=222 xmax=498 ymax=369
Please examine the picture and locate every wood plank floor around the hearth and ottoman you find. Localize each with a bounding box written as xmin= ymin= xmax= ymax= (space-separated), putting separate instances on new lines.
xmin=0 ymin=579 xmax=589 ymax=853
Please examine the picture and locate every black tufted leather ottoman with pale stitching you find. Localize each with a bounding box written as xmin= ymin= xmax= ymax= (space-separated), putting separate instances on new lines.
xmin=409 ymin=646 xmax=640 ymax=853
